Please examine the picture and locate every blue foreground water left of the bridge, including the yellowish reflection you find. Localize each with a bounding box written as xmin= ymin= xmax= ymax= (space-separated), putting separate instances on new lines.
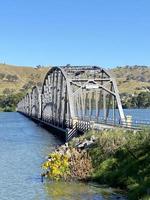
xmin=0 ymin=113 xmax=125 ymax=200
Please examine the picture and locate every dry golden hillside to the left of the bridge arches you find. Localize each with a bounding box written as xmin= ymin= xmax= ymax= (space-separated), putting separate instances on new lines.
xmin=0 ymin=64 xmax=48 ymax=95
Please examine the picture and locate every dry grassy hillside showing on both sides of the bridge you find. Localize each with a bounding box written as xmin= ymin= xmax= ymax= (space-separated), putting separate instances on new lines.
xmin=0 ymin=64 xmax=150 ymax=95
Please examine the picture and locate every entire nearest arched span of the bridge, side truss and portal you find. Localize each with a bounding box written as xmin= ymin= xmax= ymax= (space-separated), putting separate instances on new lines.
xmin=41 ymin=66 xmax=125 ymax=127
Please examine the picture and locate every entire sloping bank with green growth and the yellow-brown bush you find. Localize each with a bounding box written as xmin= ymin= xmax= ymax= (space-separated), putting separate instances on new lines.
xmin=43 ymin=129 xmax=150 ymax=200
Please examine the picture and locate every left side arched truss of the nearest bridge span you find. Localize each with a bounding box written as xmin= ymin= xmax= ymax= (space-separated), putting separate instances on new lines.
xmin=41 ymin=67 xmax=74 ymax=127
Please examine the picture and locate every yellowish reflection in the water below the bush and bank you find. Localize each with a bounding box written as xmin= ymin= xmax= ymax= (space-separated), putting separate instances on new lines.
xmin=44 ymin=182 xmax=126 ymax=200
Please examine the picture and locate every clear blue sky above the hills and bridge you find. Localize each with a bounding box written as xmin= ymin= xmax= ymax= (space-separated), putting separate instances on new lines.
xmin=0 ymin=0 xmax=150 ymax=67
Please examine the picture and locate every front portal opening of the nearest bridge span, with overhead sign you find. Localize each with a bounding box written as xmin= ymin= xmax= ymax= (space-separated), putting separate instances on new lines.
xmin=59 ymin=66 xmax=125 ymax=123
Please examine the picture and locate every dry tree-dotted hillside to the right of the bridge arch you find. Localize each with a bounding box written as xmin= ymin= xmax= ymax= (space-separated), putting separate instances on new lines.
xmin=111 ymin=65 xmax=150 ymax=94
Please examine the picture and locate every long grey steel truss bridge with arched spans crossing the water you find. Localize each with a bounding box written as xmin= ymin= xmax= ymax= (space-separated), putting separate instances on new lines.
xmin=17 ymin=65 xmax=129 ymax=140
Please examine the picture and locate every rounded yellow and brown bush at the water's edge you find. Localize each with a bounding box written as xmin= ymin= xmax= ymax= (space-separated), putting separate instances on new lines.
xmin=42 ymin=144 xmax=93 ymax=181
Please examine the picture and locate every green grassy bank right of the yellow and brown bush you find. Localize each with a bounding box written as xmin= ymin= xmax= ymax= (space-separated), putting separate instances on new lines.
xmin=89 ymin=129 xmax=150 ymax=200
